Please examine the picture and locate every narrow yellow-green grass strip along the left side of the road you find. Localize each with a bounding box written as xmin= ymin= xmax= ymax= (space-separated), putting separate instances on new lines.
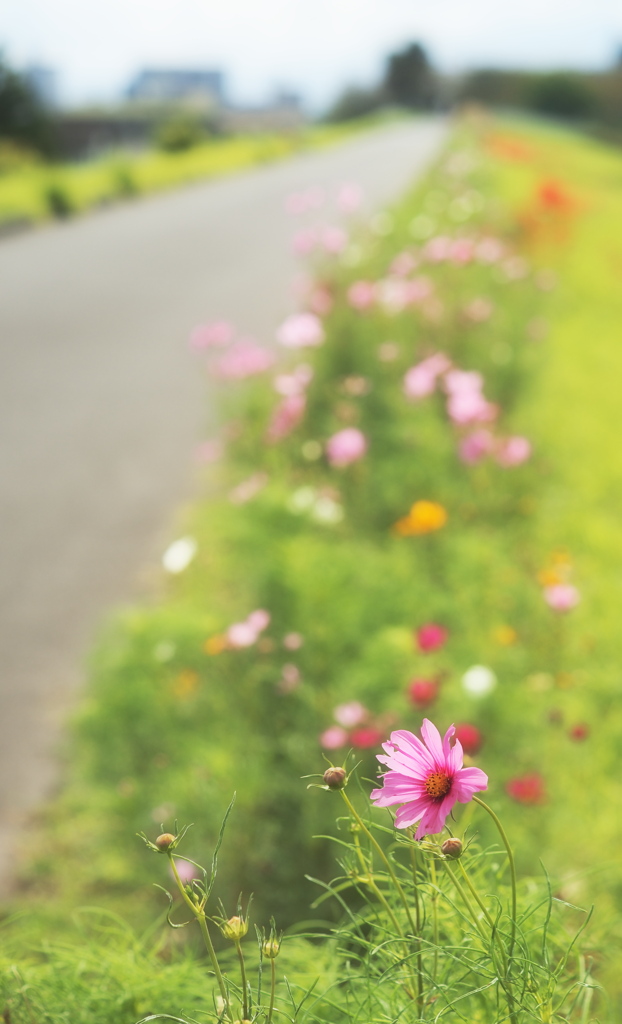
xmin=0 ymin=121 xmax=391 ymax=224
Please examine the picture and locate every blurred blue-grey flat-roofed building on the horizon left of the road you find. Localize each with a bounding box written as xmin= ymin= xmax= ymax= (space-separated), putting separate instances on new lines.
xmin=126 ymin=68 xmax=224 ymax=110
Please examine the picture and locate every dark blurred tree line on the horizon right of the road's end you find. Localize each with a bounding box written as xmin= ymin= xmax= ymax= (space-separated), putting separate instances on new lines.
xmin=327 ymin=43 xmax=622 ymax=137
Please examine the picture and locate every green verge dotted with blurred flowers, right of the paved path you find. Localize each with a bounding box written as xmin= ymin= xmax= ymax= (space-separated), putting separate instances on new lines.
xmin=1 ymin=112 xmax=622 ymax=1024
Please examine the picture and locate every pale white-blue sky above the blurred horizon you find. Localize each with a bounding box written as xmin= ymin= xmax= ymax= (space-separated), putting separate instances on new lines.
xmin=0 ymin=0 xmax=622 ymax=109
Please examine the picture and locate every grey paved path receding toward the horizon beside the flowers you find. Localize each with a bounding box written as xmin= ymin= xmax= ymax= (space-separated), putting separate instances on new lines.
xmin=0 ymin=121 xmax=446 ymax=892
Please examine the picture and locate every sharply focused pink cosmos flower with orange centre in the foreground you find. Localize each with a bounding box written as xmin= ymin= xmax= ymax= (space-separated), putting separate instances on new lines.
xmin=371 ymin=718 xmax=488 ymax=839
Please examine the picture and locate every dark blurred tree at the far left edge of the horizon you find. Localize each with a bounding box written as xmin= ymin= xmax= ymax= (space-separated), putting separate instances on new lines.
xmin=0 ymin=53 xmax=56 ymax=157
